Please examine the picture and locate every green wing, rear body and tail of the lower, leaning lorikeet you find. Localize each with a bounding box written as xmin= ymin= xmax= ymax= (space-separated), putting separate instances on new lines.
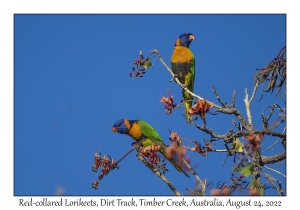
xmin=137 ymin=120 xmax=190 ymax=177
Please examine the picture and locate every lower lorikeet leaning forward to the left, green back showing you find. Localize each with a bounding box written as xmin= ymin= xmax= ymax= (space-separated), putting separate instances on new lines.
xmin=112 ymin=119 xmax=190 ymax=177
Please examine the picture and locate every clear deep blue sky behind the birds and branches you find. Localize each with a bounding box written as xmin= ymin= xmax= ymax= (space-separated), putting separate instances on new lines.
xmin=14 ymin=15 xmax=286 ymax=195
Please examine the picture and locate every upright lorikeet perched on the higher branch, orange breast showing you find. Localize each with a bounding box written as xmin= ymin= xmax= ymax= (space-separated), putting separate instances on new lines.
xmin=171 ymin=33 xmax=195 ymax=123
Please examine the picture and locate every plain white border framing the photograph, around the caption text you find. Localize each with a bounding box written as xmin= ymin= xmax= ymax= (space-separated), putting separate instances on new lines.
xmin=0 ymin=0 xmax=300 ymax=209
